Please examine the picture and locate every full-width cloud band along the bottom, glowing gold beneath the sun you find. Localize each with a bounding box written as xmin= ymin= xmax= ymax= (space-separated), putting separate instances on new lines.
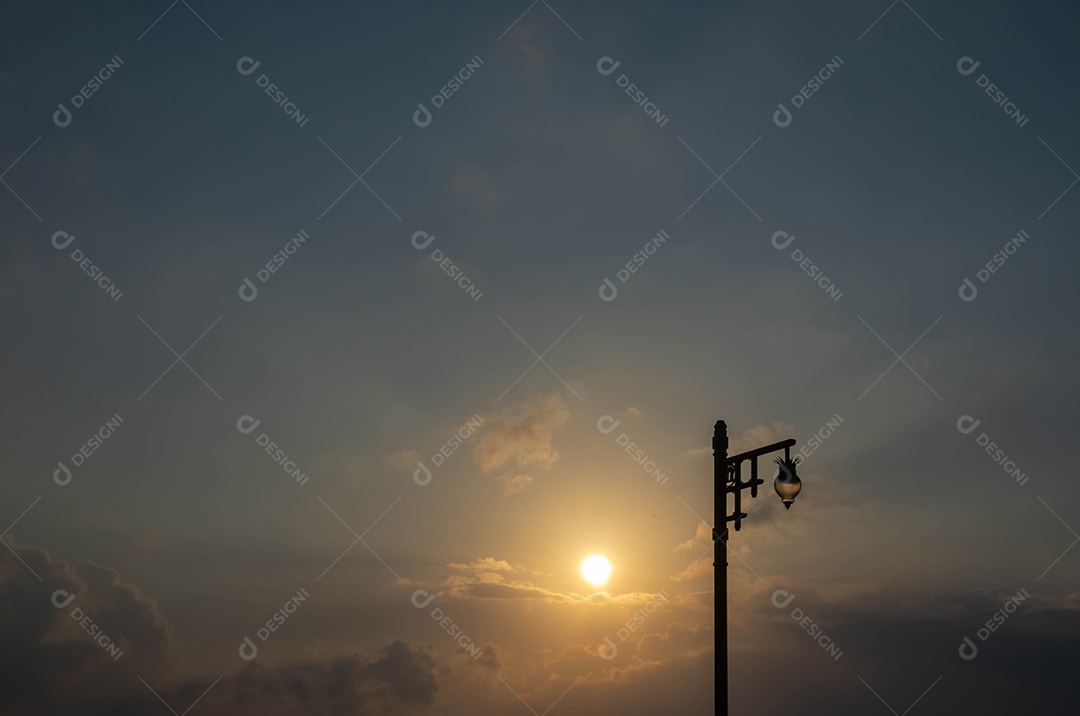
xmin=16 ymin=535 xmax=1080 ymax=716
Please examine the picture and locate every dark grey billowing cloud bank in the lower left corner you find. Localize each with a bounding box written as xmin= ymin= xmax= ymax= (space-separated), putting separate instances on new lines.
xmin=0 ymin=545 xmax=442 ymax=716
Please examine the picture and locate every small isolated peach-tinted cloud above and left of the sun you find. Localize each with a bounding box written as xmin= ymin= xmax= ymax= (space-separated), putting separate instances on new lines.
xmin=473 ymin=394 xmax=570 ymax=491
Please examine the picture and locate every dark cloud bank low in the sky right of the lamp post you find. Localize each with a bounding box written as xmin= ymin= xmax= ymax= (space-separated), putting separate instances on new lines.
xmin=731 ymin=580 xmax=1080 ymax=716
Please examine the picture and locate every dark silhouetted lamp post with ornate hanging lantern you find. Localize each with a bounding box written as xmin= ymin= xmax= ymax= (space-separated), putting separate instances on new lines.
xmin=713 ymin=420 xmax=802 ymax=716
